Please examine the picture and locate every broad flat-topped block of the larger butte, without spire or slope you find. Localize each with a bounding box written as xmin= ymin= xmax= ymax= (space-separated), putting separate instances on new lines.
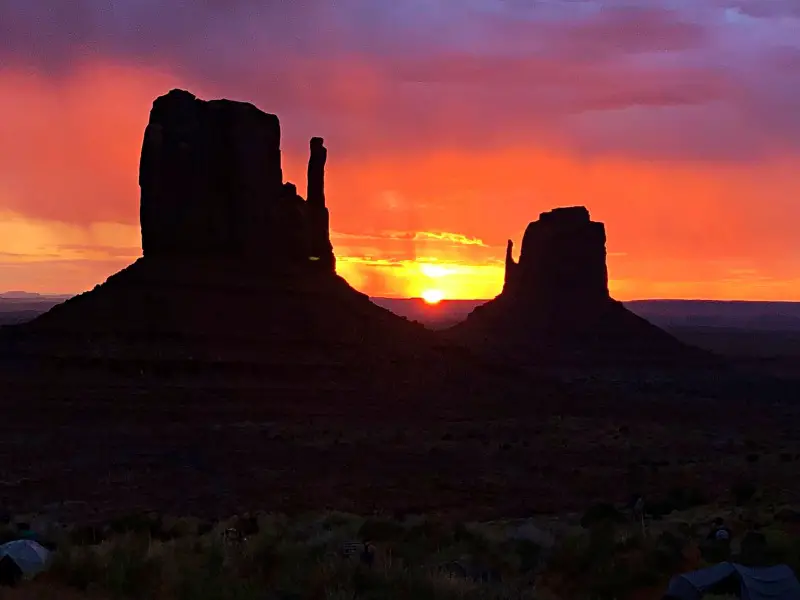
xmin=139 ymin=90 xmax=283 ymax=261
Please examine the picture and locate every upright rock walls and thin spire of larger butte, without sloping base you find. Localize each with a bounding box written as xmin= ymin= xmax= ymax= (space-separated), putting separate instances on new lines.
xmin=139 ymin=90 xmax=334 ymax=271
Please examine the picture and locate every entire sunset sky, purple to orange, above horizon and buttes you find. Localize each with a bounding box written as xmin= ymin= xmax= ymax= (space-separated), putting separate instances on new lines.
xmin=0 ymin=0 xmax=800 ymax=300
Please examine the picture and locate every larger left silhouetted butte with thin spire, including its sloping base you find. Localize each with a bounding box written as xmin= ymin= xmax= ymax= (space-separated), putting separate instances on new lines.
xmin=12 ymin=90 xmax=434 ymax=376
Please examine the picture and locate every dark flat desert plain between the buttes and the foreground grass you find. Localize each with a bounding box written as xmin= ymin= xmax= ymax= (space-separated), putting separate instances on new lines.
xmin=0 ymin=354 xmax=800 ymax=521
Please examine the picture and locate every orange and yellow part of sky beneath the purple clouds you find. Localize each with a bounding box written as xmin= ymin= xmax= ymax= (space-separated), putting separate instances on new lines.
xmin=0 ymin=2 xmax=800 ymax=300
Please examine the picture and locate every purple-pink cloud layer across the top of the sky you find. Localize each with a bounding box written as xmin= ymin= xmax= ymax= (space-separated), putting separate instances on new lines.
xmin=0 ymin=0 xmax=800 ymax=160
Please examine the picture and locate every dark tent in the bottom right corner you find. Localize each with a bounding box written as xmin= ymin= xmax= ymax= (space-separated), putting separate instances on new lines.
xmin=665 ymin=562 xmax=800 ymax=600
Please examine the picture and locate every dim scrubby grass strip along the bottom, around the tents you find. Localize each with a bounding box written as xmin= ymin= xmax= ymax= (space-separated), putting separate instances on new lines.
xmin=2 ymin=504 xmax=800 ymax=600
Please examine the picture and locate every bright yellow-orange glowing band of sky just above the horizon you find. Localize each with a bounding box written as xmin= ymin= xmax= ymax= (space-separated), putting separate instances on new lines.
xmin=0 ymin=213 xmax=800 ymax=301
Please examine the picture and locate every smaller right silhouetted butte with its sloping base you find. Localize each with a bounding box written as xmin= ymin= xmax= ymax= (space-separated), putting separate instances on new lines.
xmin=446 ymin=206 xmax=703 ymax=364
